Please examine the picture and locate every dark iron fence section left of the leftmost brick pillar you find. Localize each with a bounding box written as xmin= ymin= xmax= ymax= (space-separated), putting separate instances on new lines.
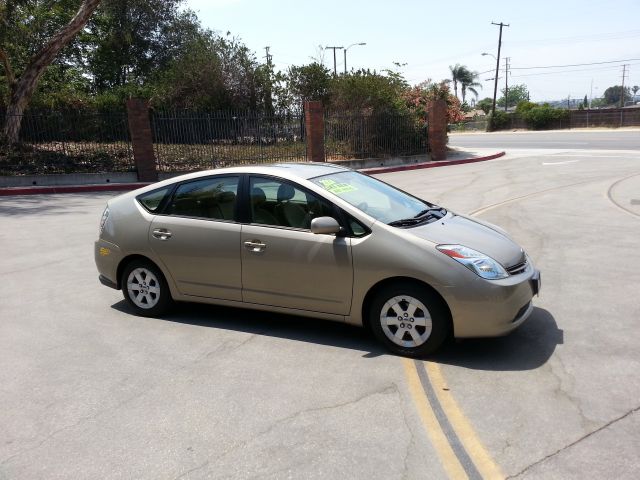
xmin=0 ymin=111 xmax=135 ymax=175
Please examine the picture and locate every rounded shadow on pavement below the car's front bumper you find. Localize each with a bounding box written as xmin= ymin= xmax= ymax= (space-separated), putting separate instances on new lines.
xmin=430 ymin=307 xmax=564 ymax=371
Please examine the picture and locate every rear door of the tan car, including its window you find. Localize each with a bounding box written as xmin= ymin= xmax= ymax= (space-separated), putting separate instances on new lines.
xmin=149 ymin=175 xmax=242 ymax=301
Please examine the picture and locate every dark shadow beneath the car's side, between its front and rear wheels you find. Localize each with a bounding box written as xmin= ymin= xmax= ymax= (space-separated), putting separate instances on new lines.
xmin=111 ymin=300 xmax=387 ymax=358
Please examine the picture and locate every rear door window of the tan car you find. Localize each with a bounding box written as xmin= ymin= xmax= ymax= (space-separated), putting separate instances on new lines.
xmin=165 ymin=176 xmax=239 ymax=220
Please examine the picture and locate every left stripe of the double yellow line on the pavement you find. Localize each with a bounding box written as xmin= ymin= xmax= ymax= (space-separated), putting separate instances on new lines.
xmin=402 ymin=358 xmax=469 ymax=480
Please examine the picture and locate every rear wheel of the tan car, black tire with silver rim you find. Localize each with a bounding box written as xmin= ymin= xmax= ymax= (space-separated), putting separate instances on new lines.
xmin=120 ymin=260 xmax=173 ymax=317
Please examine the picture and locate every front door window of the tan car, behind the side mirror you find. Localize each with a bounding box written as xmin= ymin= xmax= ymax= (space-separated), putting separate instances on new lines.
xmin=249 ymin=177 xmax=335 ymax=230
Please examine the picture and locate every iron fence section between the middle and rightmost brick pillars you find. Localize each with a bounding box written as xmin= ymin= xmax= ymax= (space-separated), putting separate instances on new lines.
xmin=324 ymin=113 xmax=429 ymax=161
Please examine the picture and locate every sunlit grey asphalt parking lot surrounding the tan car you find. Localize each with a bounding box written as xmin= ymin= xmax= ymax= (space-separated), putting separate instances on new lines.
xmin=0 ymin=149 xmax=640 ymax=479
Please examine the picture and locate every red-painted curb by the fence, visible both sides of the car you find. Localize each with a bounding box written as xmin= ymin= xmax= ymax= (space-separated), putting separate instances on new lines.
xmin=0 ymin=152 xmax=505 ymax=197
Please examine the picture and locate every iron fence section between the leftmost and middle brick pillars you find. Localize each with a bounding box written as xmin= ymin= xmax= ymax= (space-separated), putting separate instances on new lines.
xmin=151 ymin=111 xmax=306 ymax=172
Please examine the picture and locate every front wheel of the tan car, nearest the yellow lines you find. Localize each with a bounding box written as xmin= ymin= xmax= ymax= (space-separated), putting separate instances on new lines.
xmin=368 ymin=282 xmax=451 ymax=357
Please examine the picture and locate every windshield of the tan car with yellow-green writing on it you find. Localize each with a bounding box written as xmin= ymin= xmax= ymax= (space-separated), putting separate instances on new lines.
xmin=310 ymin=172 xmax=446 ymax=227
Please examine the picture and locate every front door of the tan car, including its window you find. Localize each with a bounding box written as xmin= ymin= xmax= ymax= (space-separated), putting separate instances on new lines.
xmin=241 ymin=176 xmax=353 ymax=315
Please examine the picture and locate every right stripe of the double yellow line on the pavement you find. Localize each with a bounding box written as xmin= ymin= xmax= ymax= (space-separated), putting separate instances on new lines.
xmin=424 ymin=362 xmax=505 ymax=479
